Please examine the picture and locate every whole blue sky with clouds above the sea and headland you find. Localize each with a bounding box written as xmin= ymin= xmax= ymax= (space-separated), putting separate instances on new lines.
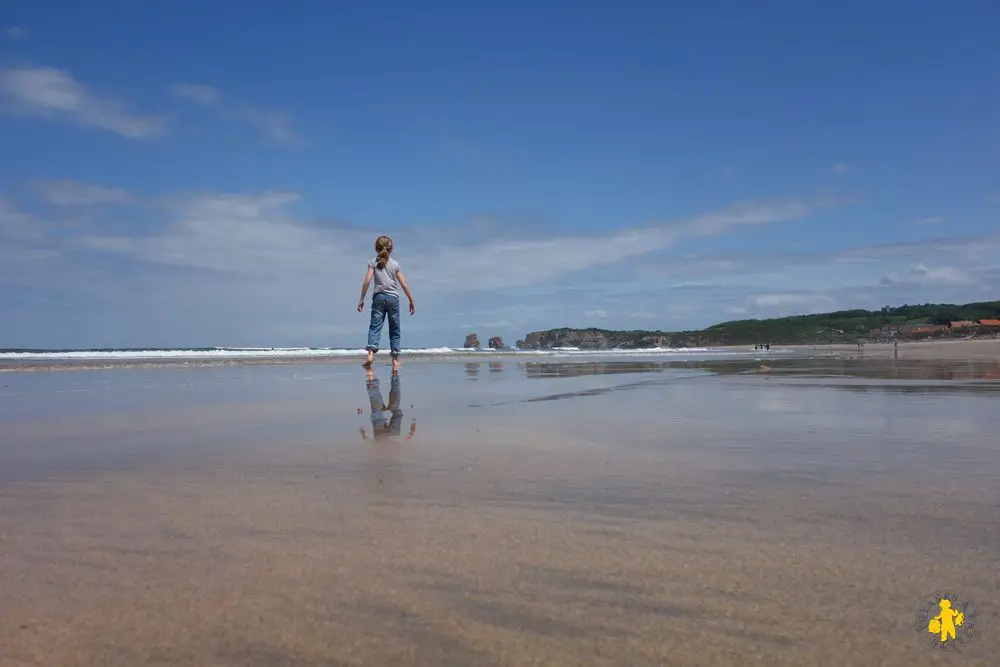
xmin=0 ymin=0 xmax=1000 ymax=347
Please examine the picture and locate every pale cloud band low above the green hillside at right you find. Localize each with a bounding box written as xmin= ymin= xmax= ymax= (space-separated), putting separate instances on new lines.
xmin=636 ymin=235 xmax=1000 ymax=325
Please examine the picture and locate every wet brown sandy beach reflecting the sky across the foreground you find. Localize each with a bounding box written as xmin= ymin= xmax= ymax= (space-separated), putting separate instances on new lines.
xmin=0 ymin=357 xmax=1000 ymax=667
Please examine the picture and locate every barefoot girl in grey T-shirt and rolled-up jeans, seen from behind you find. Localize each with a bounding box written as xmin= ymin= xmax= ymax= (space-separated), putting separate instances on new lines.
xmin=358 ymin=236 xmax=415 ymax=371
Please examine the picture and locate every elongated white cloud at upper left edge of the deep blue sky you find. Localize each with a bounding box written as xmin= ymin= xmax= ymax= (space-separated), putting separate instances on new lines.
xmin=0 ymin=67 xmax=166 ymax=139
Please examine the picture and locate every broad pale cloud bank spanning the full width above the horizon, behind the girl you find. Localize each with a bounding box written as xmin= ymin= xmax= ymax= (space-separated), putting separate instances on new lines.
xmin=0 ymin=181 xmax=1000 ymax=346
